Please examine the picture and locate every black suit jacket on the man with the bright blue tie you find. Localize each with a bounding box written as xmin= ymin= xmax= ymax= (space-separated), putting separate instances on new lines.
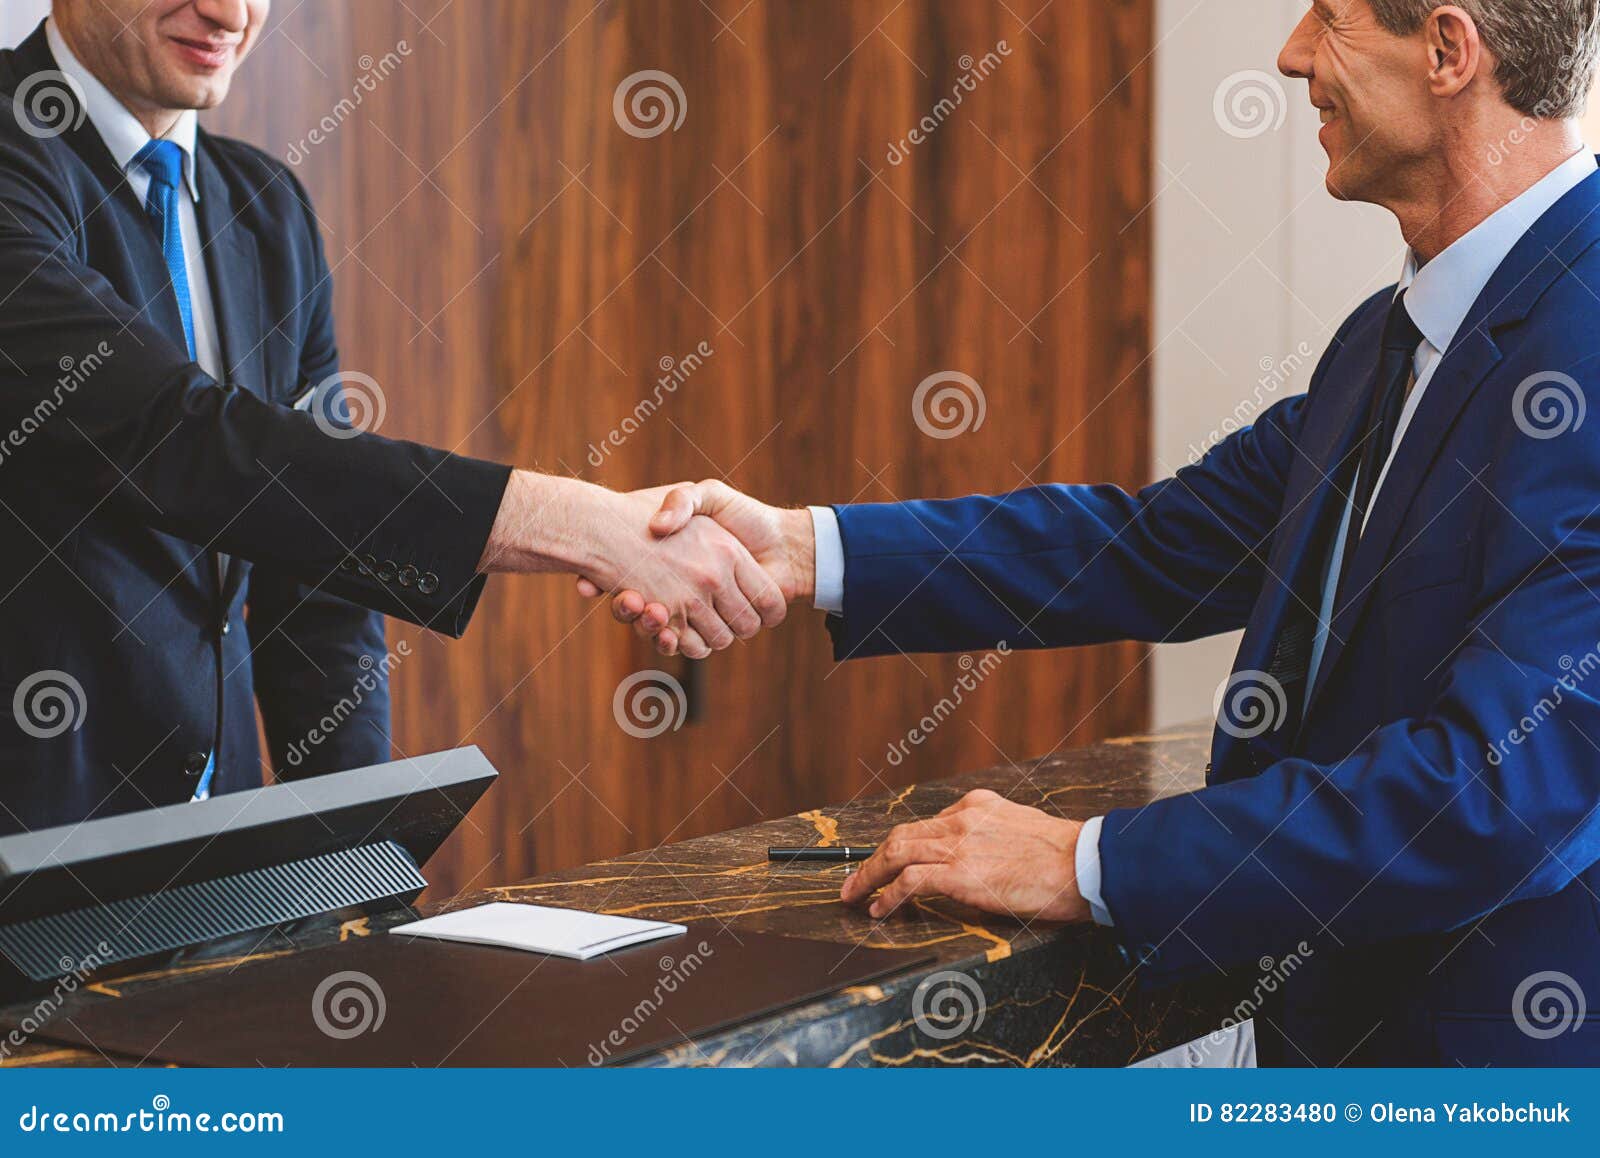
xmin=0 ymin=27 xmax=507 ymax=833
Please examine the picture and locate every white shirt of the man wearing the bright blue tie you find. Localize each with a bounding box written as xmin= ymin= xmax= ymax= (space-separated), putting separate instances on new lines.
xmin=45 ymin=21 xmax=222 ymax=382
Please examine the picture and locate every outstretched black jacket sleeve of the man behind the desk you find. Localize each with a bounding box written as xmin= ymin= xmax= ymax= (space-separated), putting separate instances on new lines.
xmin=0 ymin=109 xmax=509 ymax=635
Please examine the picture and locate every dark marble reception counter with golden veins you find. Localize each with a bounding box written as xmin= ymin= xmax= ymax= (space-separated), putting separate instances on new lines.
xmin=0 ymin=728 xmax=1243 ymax=1067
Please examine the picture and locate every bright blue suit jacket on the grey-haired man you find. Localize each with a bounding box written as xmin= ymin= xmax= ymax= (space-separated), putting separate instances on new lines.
xmin=834 ymin=164 xmax=1600 ymax=1065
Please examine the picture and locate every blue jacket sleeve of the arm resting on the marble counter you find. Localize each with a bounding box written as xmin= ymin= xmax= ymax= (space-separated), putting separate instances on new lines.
xmin=1099 ymin=374 xmax=1600 ymax=980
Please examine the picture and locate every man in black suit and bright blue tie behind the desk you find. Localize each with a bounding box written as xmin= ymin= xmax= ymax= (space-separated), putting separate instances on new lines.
xmin=0 ymin=0 xmax=784 ymax=833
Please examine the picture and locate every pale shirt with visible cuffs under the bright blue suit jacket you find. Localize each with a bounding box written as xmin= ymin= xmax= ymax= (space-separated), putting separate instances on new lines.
xmin=811 ymin=149 xmax=1595 ymax=924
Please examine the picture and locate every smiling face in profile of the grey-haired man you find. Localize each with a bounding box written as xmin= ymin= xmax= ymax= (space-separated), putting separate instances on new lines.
xmin=1278 ymin=0 xmax=1437 ymax=203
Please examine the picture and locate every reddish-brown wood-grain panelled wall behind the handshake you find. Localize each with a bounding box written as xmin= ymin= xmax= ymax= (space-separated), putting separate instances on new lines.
xmin=208 ymin=0 xmax=1152 ymax=896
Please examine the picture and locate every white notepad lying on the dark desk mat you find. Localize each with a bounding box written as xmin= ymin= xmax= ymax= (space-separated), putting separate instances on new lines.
xmin=389 ymin=900 xmax=688 ymax=961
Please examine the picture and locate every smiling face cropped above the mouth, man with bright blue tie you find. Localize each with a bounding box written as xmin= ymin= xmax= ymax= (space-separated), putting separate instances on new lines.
xmin=51 ymin=0 xmax=272 ymax=115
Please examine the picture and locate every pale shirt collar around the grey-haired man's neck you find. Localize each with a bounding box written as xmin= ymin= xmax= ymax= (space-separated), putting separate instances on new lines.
xmin=1398 ymin=149 xmax=1597 ymax=353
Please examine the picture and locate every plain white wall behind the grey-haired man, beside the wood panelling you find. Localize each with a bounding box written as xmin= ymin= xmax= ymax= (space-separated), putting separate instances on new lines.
xmin=1152 ymin=0 xmax=1405 ymax=726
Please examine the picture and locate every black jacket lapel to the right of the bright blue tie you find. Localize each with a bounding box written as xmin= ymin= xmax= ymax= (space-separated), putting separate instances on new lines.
xmin=195 ymin=133 xmax=267 ymax=609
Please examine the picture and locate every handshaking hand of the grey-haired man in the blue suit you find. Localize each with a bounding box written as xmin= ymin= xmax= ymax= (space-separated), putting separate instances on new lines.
xmin=578 ymin=478 xmax=816 ymax=656
